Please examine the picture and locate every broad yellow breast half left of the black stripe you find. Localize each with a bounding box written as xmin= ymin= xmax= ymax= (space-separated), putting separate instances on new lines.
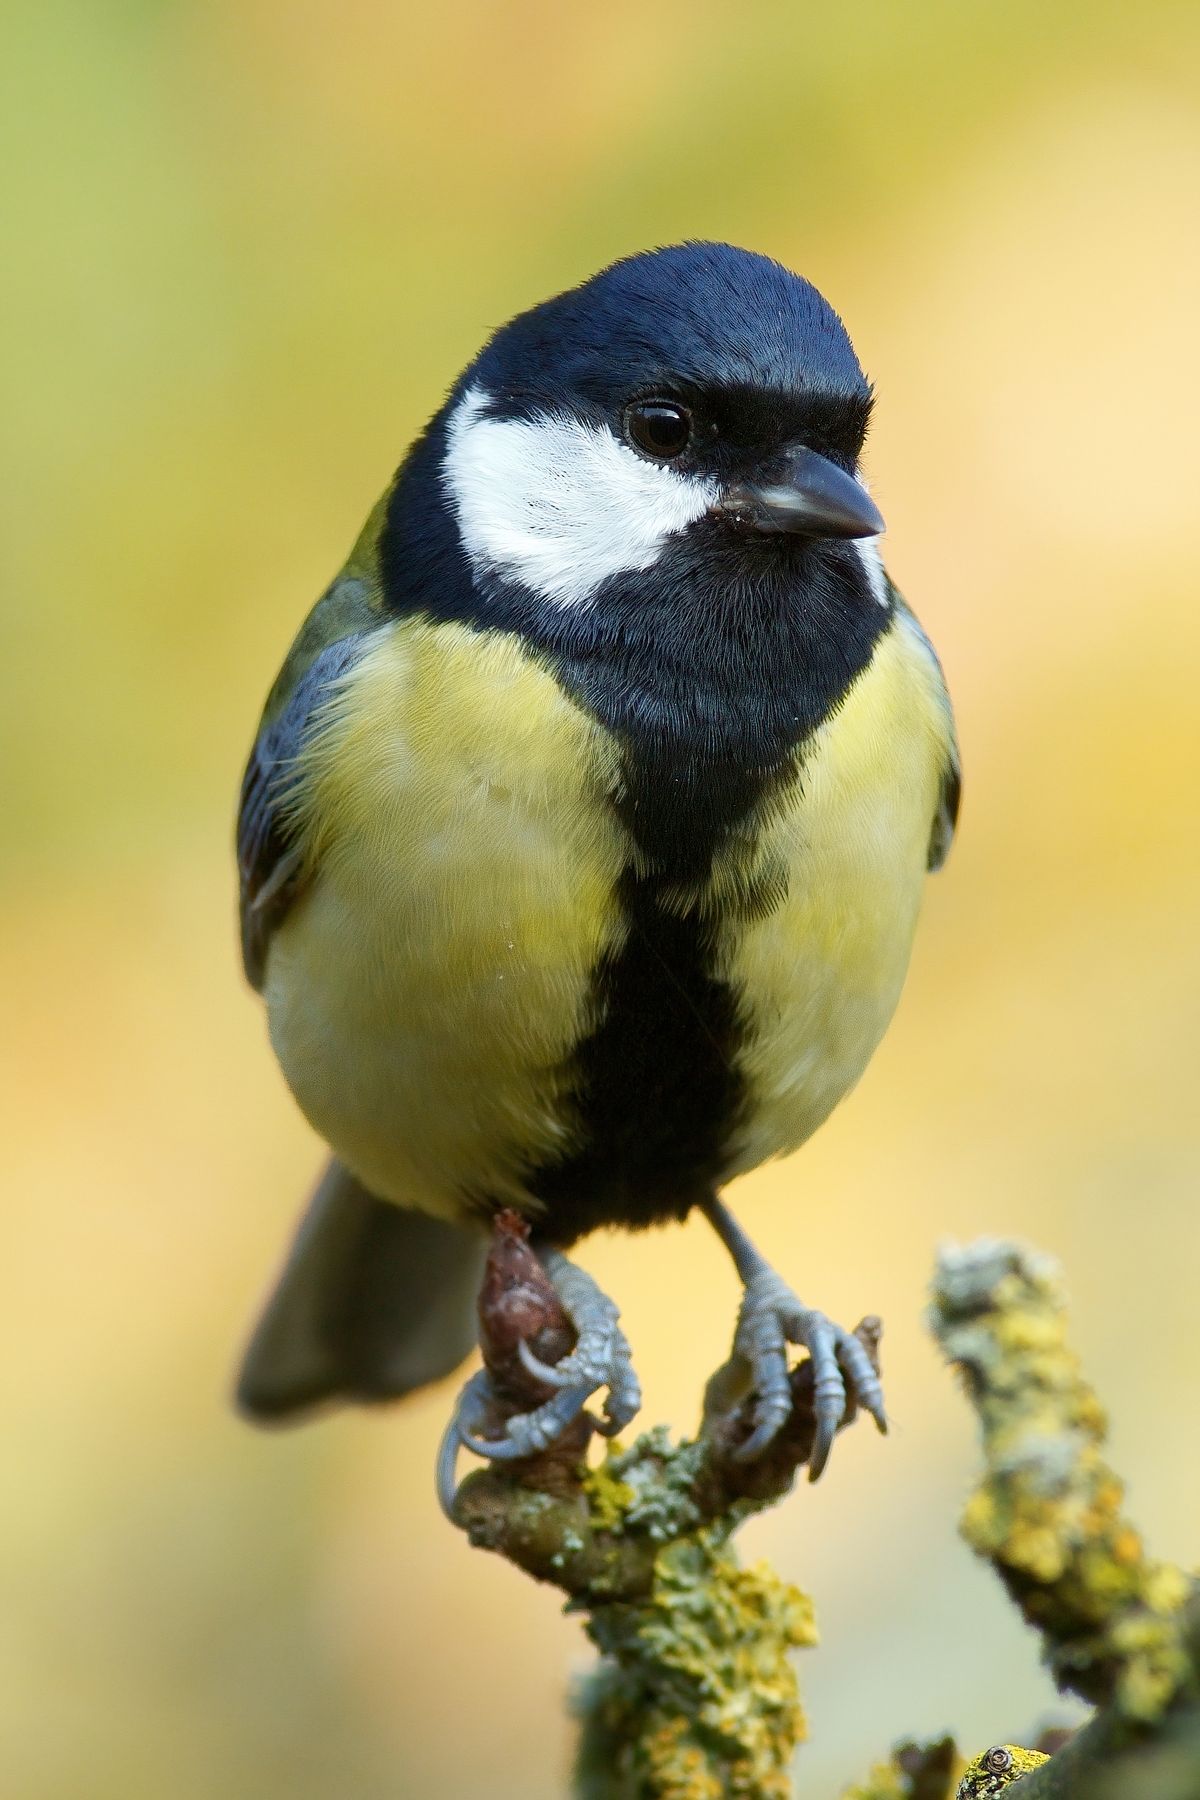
xmin=264 ymin=621 xmax=628 ymax=1213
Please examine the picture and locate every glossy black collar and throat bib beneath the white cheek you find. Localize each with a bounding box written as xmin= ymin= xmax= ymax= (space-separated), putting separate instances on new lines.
xmin=380 ymin=419 xmax=892 ymax=880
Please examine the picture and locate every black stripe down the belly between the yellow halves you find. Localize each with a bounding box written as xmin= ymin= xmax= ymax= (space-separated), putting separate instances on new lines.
xmin=527 ymin=723 xmax=795 ymax=1244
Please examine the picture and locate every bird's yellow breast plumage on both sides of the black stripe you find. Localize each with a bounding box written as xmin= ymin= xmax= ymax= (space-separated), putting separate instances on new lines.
xmin=264 ymin=614 xmax=952 ymax=1215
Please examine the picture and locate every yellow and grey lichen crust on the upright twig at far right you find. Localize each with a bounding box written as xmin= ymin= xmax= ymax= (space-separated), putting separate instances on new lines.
xmin=932 ymin=1242 xmax=1191 ymax=1719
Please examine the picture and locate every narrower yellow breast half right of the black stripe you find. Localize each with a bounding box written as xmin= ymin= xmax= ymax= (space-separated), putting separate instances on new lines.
xmin=711 ymin=612 xmax=954 ymax=1175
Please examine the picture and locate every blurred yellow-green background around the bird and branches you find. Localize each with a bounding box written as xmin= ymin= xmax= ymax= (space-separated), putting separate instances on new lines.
xmin=0 ymin=0 xmax=1200 ymax=1800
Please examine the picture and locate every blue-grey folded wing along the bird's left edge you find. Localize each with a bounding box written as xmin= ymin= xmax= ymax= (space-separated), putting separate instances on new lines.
xmin=237 ymin=574 xmax=380 ymax=988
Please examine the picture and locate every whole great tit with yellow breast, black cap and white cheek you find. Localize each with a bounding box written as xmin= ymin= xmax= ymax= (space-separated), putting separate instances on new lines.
xmin=237 ymin=241 xmax=961 ymax=1505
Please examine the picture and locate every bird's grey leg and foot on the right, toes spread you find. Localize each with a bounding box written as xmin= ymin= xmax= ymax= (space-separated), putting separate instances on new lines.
xmin=702 ymin=1195 xmax=887 ymax=1481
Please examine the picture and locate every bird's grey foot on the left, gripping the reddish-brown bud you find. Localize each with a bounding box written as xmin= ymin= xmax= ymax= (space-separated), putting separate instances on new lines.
xmin=437 ymin=1249 xmax=642 ymax=1514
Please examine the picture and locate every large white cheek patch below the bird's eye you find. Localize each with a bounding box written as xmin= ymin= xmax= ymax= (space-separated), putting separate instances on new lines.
xmin=443 ymin=387 xmax=718 ymax=607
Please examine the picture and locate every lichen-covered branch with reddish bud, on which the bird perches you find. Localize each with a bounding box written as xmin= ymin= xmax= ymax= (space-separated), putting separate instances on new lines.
xmin=453 ymin=1219 xmax=880 ymax=1800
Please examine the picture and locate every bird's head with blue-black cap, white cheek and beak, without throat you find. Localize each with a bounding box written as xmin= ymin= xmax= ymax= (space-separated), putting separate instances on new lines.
xmin=426 ymin=243 xmax=883 ymax=608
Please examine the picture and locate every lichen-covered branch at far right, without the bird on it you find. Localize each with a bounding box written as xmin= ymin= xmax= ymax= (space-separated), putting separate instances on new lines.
xmin=930 ymin=1242 xmax=1200 ymax=1800
